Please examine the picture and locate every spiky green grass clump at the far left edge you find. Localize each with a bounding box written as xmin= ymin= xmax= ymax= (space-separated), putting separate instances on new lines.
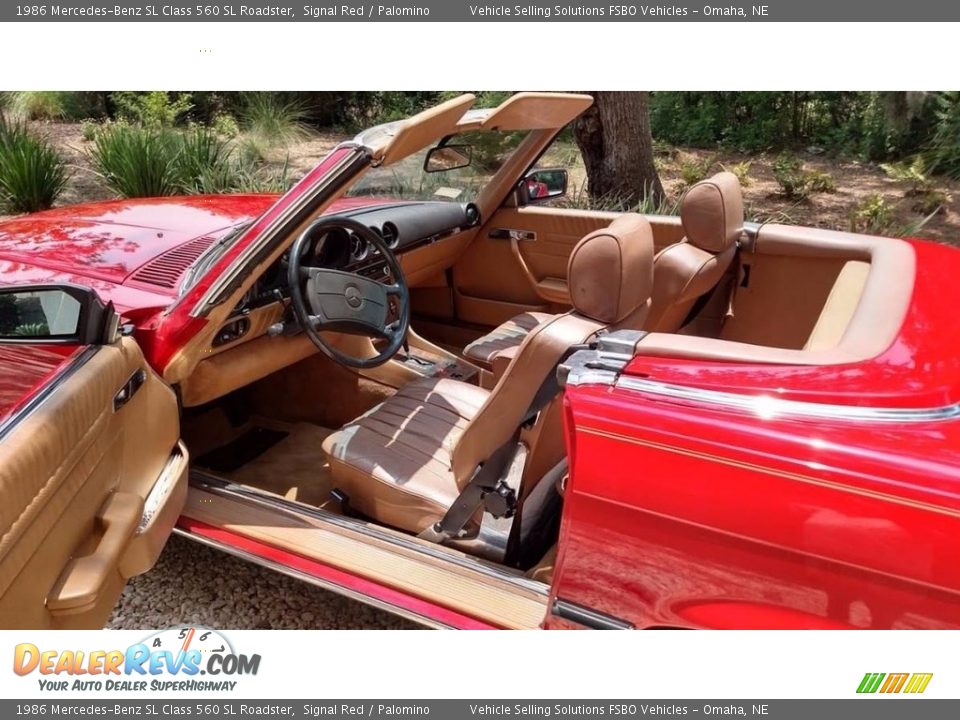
xmin=0 ymin=115 xmax=69 ymax=212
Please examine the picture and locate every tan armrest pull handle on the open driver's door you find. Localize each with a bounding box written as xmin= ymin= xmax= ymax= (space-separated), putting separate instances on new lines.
xmin=47 ymin=493 xmax=143 ymax=615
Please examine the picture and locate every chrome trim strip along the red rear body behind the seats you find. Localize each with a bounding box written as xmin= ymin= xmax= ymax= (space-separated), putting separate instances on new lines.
xmin=596 ymin=371 xmax=960 ymax=423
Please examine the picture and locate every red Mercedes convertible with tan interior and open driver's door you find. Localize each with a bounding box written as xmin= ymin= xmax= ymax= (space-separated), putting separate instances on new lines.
xmin=0 ymin=93 xmax=960 ymax=628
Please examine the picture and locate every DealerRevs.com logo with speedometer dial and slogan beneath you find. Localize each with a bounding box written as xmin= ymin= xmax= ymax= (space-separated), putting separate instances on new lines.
xmin=13 ymin=627 xmax=260 ymax=692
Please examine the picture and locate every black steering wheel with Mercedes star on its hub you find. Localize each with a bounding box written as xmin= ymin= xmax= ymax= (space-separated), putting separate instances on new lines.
xmin=287 ymin=217 xmax=410 ymax=369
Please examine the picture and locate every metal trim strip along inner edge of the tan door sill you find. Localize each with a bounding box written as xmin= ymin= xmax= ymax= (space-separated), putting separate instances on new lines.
xmin=190 ymin=468 xmax=550 ymax=597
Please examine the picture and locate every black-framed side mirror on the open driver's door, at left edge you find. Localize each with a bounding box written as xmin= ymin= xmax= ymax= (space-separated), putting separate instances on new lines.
xmin=0 ymin=284 xmax=118 ymax=345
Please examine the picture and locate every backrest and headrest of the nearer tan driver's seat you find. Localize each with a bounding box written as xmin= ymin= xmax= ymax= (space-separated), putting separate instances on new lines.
xmin=452 ymin=214 xmax=653 ymax=488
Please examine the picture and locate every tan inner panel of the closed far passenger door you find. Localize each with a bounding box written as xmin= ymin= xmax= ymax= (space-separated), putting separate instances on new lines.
xmin=453 ymin=205 xmax=683 ymax=325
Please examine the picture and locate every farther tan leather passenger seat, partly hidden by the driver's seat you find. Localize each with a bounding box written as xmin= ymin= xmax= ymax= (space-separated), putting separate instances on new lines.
xmin=463 ymin=172 xmax=743 ymax=368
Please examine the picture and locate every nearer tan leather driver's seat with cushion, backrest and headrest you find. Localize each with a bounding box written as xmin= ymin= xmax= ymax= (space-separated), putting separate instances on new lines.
xmin=323 ymin=215 xmax=653 ymax=533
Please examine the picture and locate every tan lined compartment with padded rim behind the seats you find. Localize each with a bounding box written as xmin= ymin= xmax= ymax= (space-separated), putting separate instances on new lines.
xmin=636 ymin=224 xmax=916 ymax=365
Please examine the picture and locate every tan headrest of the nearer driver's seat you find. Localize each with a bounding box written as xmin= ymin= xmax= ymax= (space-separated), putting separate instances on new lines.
xmin=567 ymin=214 xmax=653 ymax=324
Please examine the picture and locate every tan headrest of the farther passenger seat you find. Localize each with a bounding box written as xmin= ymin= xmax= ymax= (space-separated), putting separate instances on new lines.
xmin=680 ymin=172 xmax=743 ymax=253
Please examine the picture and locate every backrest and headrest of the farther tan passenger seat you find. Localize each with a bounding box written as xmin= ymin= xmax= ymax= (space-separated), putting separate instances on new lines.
xmin=643 ymin=172 xmax=743 ymax=333
